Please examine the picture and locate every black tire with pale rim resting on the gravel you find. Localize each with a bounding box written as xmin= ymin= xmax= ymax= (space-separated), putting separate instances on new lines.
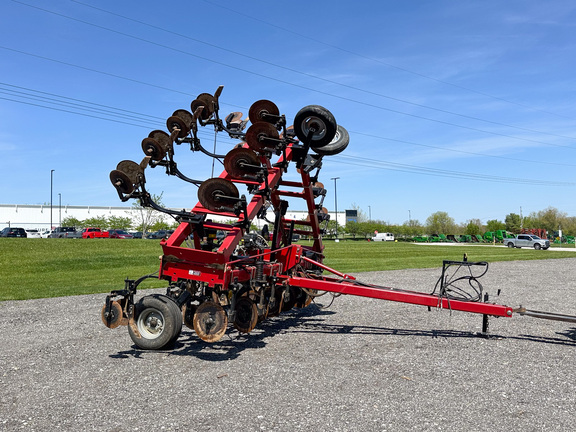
xmin=128 ymin=294 xmax=182 ymax=350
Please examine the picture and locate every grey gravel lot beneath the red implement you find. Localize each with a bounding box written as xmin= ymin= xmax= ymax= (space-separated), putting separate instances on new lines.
xmin=0 ymin=258 xmax=576 ymax=432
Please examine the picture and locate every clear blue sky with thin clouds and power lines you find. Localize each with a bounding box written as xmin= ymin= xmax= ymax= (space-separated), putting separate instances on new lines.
xmin=0 ymin=0 xmax=576 ymax=224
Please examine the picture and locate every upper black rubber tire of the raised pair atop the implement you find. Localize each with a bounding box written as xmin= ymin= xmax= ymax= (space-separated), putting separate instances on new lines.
xmin=294 ymin=105 xmax=338 ymax=148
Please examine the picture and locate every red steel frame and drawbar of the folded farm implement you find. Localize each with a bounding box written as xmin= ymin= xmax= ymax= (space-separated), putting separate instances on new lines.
xmin=154 ymin=140 xmax=513 ymax=317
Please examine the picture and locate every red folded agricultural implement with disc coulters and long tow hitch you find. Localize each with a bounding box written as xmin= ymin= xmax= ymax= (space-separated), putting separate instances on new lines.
xmin=101 ymin=87 xmax=576 ymax=349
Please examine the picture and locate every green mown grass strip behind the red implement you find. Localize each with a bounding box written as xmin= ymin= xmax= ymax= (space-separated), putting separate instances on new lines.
xmin=0 ymin=238 xmax=576 ymax=301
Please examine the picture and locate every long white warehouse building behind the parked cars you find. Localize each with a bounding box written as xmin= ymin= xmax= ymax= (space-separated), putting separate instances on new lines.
xmin=0 ymin=204 xmax=346 ymax=231
